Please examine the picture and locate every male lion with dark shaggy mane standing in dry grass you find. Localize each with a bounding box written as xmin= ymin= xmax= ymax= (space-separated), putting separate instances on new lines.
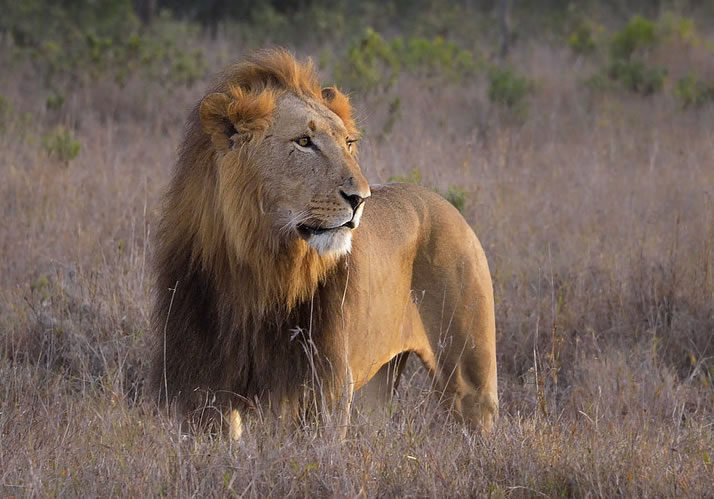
xmin=152 ymin=50 xmax=498 ymax=437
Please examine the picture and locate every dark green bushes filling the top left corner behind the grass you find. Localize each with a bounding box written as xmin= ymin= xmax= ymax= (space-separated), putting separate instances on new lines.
xmin=0 ymin=0 xmax=204 ymax=90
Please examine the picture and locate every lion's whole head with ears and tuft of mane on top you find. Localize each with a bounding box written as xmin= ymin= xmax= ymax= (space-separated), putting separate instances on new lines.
xmin=200 ymin=51 xmax=370 ymax=262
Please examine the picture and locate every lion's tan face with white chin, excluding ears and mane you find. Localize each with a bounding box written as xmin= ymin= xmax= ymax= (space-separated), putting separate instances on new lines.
xmin=257 ymin=94 xmax=370 ymax=254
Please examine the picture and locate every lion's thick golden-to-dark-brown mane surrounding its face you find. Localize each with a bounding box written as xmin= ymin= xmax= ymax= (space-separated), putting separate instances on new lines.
xmin=153 ymin=50 xmax=357 ymax=418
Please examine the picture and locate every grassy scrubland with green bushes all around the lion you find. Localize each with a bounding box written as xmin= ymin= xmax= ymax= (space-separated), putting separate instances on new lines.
xmin=0 ymin=0 xmax=714 ymax=497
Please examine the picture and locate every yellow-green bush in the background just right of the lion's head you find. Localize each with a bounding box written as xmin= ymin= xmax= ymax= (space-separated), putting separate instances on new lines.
xmin=334 ymin=28 xmax=476 ymax=91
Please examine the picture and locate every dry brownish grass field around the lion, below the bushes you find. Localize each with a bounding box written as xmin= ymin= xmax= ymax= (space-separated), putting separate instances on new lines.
xmin=0 ymin=36 xmax=714 ymax=497
